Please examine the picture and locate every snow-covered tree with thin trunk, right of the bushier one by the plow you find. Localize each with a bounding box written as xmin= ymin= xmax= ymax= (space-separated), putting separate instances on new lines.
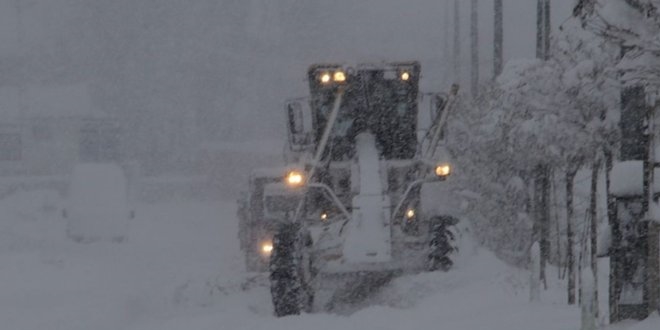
xmin=553 ymin=12 xmax=620 ymax=304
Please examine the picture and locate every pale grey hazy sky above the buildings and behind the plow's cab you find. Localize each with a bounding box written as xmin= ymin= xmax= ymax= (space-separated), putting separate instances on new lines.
xmin=0 ymin=0 xmax=574 ymax=174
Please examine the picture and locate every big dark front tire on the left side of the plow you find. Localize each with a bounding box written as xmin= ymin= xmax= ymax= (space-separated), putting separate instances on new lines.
xmin=269 ymin=224 xmax=314 ymax=317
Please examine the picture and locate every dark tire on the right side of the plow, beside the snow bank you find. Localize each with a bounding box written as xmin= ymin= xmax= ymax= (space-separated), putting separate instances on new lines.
xmin=428 ymin=216 xmax=458 ymax=271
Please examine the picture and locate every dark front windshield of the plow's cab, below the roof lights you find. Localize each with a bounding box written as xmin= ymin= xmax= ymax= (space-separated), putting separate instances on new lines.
xmin=311 ymin=65 xmax=417 ymax=160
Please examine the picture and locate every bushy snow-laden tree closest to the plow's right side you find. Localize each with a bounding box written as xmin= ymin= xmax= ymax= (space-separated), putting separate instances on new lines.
xmin=453 ymin=60 xmax=570 ymax=262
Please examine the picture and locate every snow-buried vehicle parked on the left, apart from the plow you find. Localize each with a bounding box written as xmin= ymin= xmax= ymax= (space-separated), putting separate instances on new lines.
xmin=62 ymin=163 xmax=134 ymax=242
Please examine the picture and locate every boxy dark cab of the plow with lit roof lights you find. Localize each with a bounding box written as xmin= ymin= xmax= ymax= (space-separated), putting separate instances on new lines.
xmin=308 ymin=62 xmax=420 ymax=161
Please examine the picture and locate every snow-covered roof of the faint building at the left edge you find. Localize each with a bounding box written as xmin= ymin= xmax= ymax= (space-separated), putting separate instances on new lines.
xmin=0 ymin=83 xmax=104 ymax=121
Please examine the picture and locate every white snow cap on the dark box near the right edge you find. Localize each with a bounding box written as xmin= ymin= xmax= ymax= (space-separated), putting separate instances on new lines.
xmin=610 ymin=160 xmax=660 ymax=197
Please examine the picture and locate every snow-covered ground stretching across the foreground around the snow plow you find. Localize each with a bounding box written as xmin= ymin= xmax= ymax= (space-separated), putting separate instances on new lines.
xmin=0 ymin=191 xmax=660 ymax=330
